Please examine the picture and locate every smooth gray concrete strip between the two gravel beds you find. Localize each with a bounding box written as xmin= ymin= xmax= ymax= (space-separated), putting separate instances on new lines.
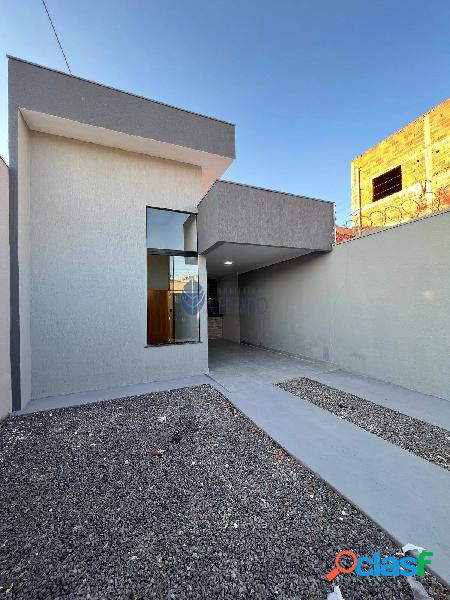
xmin=227 ymin=384 xmax=450 ymax=585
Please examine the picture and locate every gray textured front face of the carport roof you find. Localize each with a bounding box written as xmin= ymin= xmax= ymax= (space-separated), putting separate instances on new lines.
xmin=198 ymin=181 xmax=334 ymax=252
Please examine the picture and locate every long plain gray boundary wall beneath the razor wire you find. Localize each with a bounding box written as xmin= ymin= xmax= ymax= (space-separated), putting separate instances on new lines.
xmin=239 ymin=213 xmax=450 ymax=400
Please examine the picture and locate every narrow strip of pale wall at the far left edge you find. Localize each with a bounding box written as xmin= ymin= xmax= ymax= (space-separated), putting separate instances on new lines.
xmin=0 ymin=157 xmax=11 ymax=419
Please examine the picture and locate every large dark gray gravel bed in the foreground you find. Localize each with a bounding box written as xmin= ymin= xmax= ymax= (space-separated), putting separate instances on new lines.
xmin=0 ymin=386 xmax=447 ymax=600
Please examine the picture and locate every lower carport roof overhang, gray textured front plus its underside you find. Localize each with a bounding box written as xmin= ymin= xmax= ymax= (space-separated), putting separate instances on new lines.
xmin=198 ymin=181 xmax=334 ymax=279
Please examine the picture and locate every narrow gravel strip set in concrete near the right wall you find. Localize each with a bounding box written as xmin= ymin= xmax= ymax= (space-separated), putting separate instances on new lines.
xmin=277 ymin=377 xmax=450 ymax=470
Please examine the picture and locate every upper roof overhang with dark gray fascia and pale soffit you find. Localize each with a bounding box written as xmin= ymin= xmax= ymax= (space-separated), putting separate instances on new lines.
xmin=9 ymin=57 xmax=235 ymax=193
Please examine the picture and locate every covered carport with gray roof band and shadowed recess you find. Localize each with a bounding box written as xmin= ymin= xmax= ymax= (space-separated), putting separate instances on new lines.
xmin=198 ymin=181 xmax=334 ymax=371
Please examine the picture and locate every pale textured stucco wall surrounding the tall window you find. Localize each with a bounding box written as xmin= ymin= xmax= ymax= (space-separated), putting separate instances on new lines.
xmin=30 ymin=133 xmax=208 ymax=398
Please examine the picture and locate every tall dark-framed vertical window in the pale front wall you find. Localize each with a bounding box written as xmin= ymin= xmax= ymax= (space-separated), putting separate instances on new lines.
xmin=147 ymin=208 xmax=200 ymax=346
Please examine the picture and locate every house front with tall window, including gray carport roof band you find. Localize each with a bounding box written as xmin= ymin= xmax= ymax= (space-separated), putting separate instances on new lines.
xmin=2 ymin=57 xmax=334 ymax=410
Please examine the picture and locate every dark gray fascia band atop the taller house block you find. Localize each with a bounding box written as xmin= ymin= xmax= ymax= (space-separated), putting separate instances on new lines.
xmin=8 ymin=58 xmax=235 ymax=158
